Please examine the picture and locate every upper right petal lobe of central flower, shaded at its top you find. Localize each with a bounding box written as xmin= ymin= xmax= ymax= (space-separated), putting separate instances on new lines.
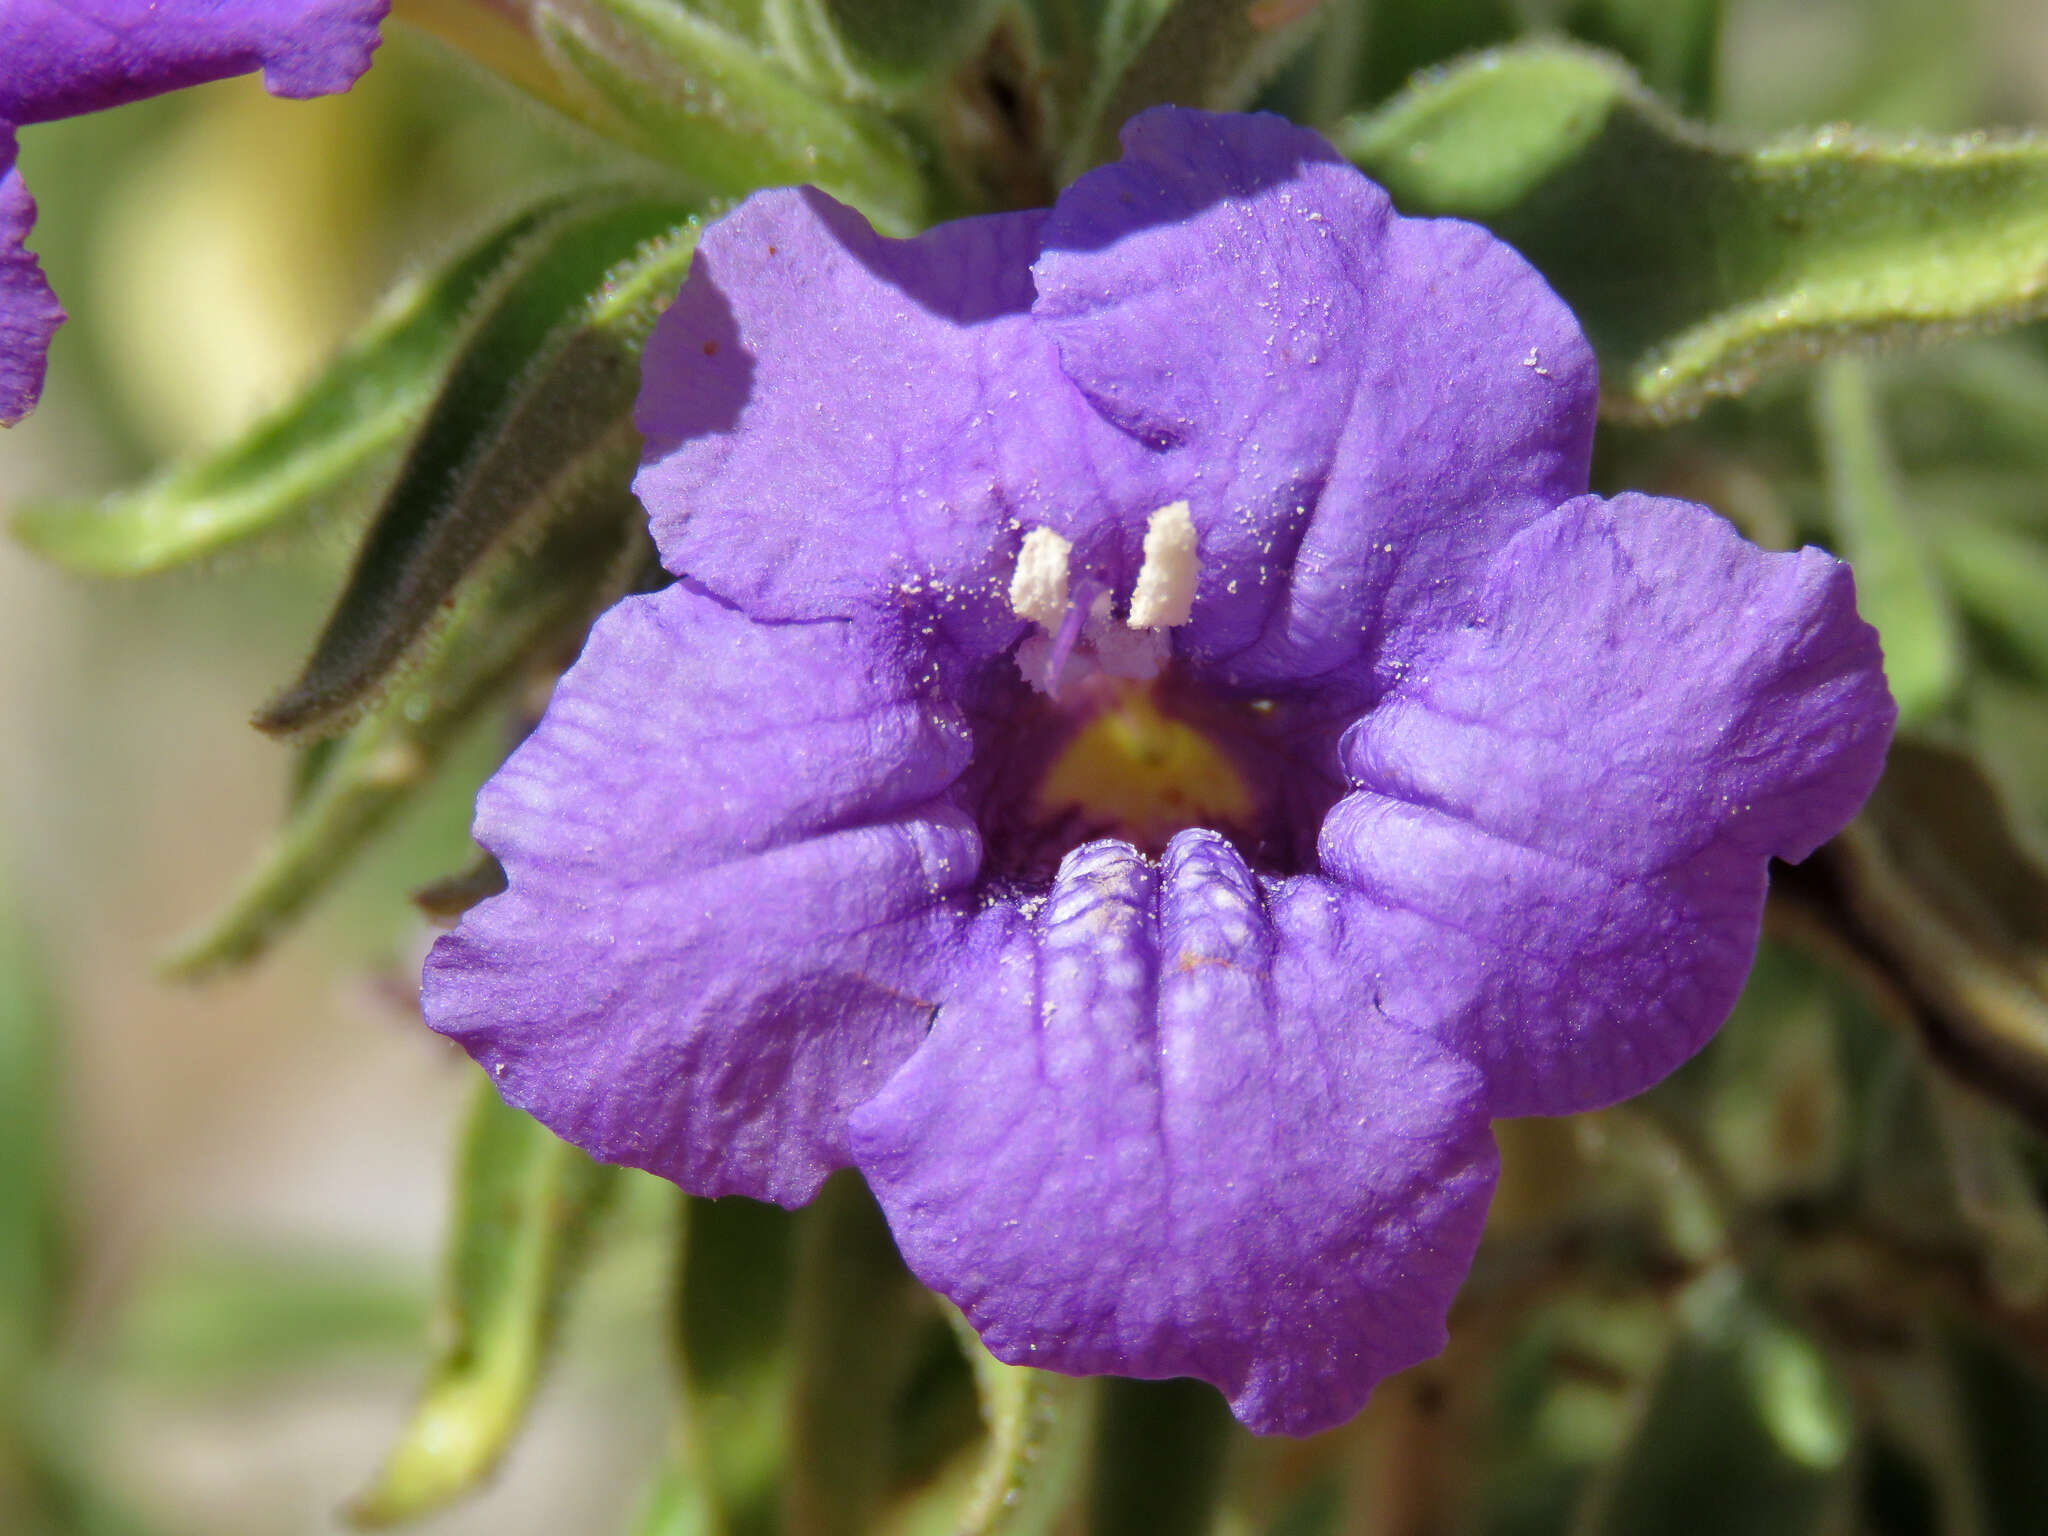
xmin=1034 ymin=109 xmax=1597 ymax=684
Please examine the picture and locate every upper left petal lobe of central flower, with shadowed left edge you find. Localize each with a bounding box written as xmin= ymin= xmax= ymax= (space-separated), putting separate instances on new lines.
xmin=635 ymin=188 xmax=1157 ymax=637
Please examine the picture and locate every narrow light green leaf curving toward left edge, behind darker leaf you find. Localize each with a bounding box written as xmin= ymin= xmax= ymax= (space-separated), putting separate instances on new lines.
xmin=14 ymin=197 xmax=567 ymax=575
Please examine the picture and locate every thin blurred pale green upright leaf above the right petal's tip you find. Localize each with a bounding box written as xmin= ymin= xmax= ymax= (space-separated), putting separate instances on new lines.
xmin=1815 ymin=358 xmax=1962 ymax=725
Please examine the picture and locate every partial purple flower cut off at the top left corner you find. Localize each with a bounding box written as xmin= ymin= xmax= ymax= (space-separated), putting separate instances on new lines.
xmin=0 ymin=0 xmax=391 ymax=424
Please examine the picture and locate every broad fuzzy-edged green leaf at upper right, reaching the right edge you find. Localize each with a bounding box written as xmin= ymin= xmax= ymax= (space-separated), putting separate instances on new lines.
xmin=1339 ymin=45 xmax=2048 ymax=420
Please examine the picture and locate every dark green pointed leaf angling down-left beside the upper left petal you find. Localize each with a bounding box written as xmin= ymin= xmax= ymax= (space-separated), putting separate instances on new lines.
xmin=256 ymin=195 xmax=696 ymax=735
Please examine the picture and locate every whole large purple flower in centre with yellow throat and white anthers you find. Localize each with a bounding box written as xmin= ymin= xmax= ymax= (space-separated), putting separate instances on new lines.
xmin=426 ymin=109 xmax=1892 ymax=1434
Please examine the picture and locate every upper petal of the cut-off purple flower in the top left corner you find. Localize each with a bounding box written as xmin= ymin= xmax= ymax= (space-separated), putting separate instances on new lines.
xmin=0 ymin=0 xmax=391 ymax=125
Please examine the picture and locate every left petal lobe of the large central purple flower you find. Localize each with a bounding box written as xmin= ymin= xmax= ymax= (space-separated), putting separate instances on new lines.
xmin=422 ymin=586 xmax=981 ymax=1204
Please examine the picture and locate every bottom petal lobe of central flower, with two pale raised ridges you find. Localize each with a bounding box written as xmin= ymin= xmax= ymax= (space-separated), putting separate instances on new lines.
xmin=854 ymin=831 xmax=1495 ymax=1434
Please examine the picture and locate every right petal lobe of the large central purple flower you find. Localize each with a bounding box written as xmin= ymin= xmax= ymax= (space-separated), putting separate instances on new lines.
xmin=1323 ymin=496 xmax=1894 ymax=1116
